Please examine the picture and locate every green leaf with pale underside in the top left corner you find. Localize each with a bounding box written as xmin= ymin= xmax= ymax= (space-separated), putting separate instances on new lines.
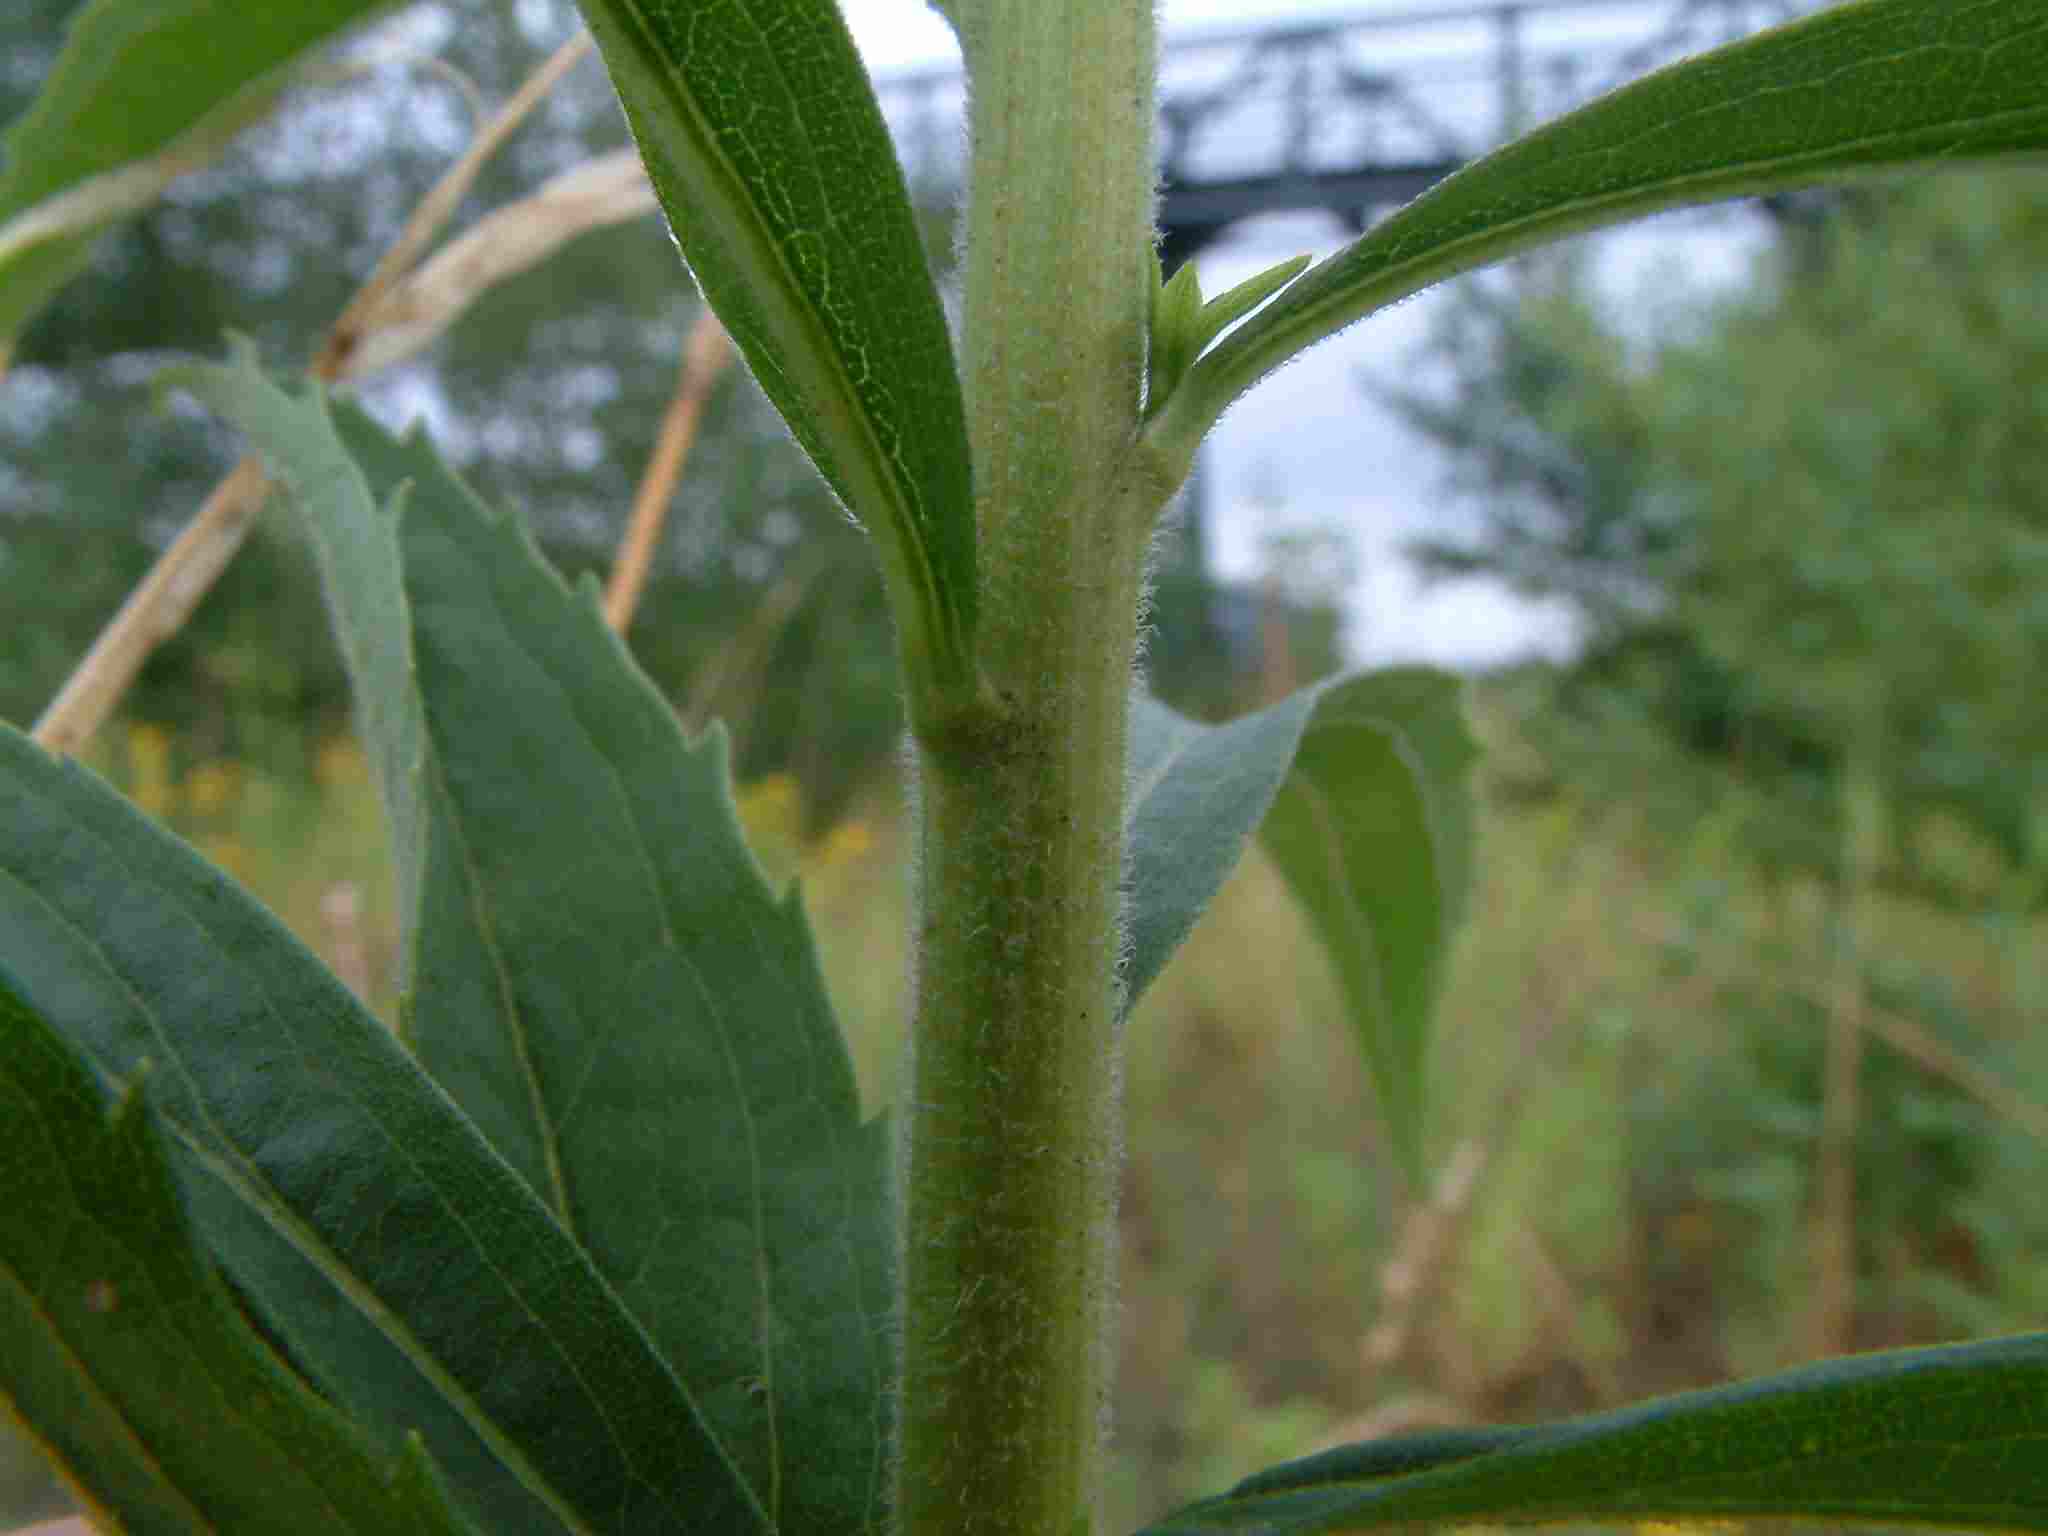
xmin=0 ymin=0 xmax=393 ymax=344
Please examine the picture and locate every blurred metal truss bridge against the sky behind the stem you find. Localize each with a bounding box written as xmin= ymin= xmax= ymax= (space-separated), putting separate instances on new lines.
xmin=877 ymin=0 xmax=1817 ymax=270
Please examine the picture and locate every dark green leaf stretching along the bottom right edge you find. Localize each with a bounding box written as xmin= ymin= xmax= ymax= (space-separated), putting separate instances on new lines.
xmin=1145 ymin=1333 xmax=2048 ymax=1536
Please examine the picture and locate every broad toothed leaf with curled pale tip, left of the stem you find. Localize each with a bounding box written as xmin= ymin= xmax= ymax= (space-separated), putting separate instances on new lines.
xmin=180 ymin=348 xmax=893 ymax=1532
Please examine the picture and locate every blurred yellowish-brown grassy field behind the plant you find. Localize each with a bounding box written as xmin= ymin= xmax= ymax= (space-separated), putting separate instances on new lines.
xmin=0 ymin=694 xmax=2048 ymax=1526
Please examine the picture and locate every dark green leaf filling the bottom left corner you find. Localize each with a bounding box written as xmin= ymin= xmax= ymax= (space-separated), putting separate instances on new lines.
xmin=0 ymin=979 xmax=465 ymax=1536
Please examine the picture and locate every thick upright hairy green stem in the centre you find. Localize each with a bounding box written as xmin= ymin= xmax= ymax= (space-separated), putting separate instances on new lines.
xmin=897 ymin=0 xmax=1171 ymax=1536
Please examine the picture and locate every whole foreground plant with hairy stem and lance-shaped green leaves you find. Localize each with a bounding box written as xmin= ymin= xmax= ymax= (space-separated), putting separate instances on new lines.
xmin=0 ymin=0 xmax=2048 ymax=1536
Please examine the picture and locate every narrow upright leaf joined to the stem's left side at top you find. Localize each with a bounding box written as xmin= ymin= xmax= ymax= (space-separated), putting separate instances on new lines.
xmin=584 ymin=0 xmax=975 ymax=725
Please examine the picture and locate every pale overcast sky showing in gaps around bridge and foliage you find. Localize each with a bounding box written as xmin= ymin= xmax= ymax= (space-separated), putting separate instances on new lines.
xmin=842 ymin=0 xmax=1777 ymax=666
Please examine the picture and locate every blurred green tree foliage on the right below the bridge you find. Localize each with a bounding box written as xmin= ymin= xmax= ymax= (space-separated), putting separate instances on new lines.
xmin=1399 ymin=172 xmax=2048 ymax=903
